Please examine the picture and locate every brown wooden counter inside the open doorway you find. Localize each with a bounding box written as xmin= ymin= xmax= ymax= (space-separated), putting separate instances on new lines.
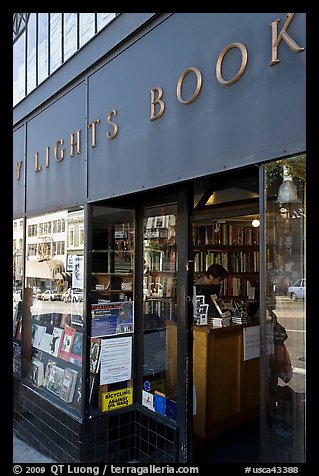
xmin=193 ymin=321 xmax=259 ymax=438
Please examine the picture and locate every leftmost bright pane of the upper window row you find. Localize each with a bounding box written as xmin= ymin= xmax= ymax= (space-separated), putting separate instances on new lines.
xmin=13 ymin=32 xmax=25 ymax=106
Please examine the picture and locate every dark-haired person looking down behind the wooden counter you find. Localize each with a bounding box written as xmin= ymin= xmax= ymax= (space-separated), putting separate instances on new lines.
xmin=194 ymin=263 xmax=228 ymax=314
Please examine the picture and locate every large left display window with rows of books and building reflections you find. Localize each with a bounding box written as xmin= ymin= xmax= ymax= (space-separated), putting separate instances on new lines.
xmin=18 ymin=209 xmax=86 ymax=414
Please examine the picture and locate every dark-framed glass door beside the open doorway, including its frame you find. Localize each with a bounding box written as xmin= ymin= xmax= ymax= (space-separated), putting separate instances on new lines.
xmin=139 ymin=185 xmax=193 ymax=463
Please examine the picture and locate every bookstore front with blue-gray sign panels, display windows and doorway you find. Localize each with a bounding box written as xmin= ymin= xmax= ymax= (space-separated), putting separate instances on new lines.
xmin=13 ymin=13 xmax=306 ymax=463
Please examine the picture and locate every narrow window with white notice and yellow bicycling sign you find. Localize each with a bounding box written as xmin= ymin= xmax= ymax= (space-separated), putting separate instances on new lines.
xmin=89 ymin=206 xmax=135 ymax=414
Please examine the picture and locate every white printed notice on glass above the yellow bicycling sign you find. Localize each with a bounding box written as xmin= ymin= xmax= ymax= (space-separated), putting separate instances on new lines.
xmin=100 ymin=336 xmax=132 ymax=385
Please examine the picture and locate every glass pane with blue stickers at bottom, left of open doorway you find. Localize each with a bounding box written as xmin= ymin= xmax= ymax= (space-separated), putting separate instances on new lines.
xmin=142 ymin=204 xmax=177 ymax=420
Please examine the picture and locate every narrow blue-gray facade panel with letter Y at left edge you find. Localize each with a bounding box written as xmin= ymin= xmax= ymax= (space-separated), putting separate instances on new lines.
xmin=12 ymin=126 xmax=25 ymax=218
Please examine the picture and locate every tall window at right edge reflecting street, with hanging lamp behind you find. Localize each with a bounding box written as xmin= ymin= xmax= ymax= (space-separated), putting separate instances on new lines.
xmin=262 ymin=154 xmax=306 ymax=463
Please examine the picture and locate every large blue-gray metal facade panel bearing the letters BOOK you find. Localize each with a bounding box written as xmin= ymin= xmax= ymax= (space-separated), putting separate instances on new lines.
xmin=88 ymin=13 xmax=306 ymax=200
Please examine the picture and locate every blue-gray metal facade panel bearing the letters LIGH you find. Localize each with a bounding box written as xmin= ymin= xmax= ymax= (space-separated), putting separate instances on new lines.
xmin=26 ymin=83 xmax=86 ymax=214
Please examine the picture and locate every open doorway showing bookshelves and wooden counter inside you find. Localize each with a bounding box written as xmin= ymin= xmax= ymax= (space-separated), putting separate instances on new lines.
xmin=192 ymin=167 xmax=260 ymax=463
